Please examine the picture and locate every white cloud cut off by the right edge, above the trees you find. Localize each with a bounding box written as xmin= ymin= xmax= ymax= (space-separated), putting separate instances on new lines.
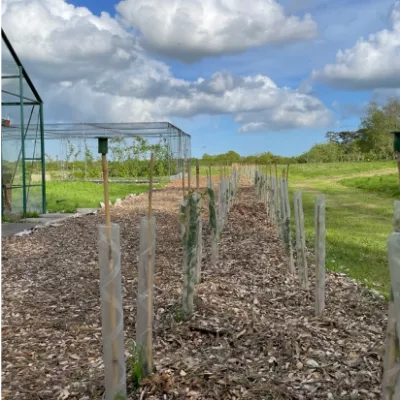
xmin=312 ymin=1 xmax=400 ymax=90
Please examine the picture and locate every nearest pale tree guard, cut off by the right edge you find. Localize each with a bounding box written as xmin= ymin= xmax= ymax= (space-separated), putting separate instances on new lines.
xmin=382 ymin=201 xmax=400 ymax=400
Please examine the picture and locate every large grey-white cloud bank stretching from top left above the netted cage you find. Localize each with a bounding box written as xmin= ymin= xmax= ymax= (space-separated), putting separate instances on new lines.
xmin=0 ymin=0 xmax=331 ymax=132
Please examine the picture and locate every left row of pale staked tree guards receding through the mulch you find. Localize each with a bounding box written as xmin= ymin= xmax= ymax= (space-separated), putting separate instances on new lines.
xmin=98 ymin=138 xmax=239 ymax=400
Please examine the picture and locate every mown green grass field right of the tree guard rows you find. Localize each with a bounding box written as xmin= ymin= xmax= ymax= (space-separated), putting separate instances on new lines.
xmin=282 ymin=162 xmax=400 ymax=296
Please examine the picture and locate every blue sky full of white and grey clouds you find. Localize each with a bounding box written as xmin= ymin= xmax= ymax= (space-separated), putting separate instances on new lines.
xmin=0 ymin=0 xmax=400 ymax=156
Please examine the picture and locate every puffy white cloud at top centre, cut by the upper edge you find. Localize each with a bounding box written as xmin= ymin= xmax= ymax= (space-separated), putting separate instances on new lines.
xmin=117 ymin=0 xmax=317 ymax=62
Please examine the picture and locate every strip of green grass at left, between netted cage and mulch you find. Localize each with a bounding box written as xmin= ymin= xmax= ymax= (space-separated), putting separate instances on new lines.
xmin=46 ymin=181 xmax=153 ymax=212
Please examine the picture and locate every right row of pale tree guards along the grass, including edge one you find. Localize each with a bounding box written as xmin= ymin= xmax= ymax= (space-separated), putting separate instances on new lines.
xmin=245 ymin=166 xmax=400 ymax=400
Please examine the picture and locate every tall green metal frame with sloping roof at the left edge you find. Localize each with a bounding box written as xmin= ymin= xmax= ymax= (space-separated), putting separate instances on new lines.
xmin=0 ymin=27 xmax=46 ymax=216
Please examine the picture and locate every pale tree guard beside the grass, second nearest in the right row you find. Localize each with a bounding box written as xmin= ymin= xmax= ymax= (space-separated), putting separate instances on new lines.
xmin=315 ymin=194 xmax=325 ymax=316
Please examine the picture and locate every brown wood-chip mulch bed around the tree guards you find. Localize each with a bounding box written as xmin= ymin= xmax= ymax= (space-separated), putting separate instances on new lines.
xmin=0 ymin=179 xmax=387 ymax=400
